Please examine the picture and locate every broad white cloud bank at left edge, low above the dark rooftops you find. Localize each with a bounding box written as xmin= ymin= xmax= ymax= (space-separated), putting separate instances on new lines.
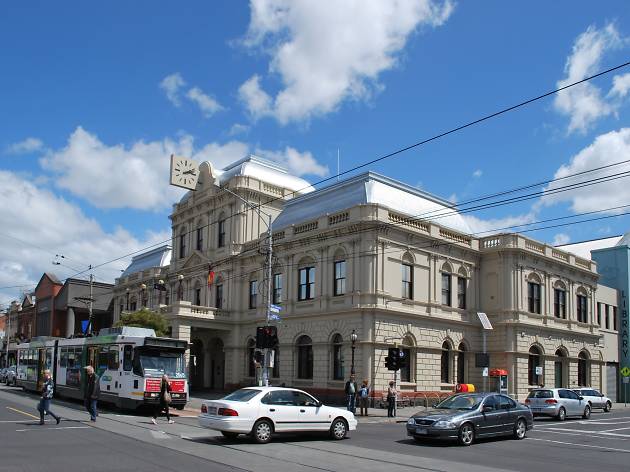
xmin=0 ymin=171 xmax=170 ymax=304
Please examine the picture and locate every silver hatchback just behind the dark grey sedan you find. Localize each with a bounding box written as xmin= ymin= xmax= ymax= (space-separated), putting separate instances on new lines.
xmin=525 ymin=388 xmax=591 ymax=421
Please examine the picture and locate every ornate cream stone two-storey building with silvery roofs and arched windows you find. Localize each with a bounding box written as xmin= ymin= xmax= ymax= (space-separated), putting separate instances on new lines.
xmin=114 ymin=156 xmax=617 ymax=399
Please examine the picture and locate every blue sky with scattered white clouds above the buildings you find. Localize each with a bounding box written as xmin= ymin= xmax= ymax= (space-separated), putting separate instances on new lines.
xmin=0 ymin=0 xmax=630 ymax=306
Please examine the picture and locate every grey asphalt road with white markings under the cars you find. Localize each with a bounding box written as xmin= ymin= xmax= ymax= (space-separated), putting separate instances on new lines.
xmin=0 ymin=387 xmax=630 ymax=472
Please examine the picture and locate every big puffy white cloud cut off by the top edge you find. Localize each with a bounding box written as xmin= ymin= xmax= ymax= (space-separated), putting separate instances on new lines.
xmin=239 ymin=0 xmax=454 ymax=124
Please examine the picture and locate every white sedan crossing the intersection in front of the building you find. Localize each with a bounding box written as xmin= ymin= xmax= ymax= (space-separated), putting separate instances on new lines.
xmin=198 ymin=387 xmax=357 ymax=444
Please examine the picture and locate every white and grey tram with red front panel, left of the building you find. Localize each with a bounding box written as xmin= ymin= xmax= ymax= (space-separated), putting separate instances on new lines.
xmin=17 ymin=326 xmax=188 ymax=409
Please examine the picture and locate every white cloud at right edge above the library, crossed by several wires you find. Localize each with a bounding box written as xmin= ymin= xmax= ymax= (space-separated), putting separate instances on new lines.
xmin=541 ymin=128 xmax=630 ymax=213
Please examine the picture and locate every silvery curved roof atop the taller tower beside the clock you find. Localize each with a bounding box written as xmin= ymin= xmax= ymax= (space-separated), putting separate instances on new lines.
xmin=180 ymin=154 xmax=315 ymax=203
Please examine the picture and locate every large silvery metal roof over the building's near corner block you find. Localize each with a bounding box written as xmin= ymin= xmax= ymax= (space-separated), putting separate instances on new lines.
xmin=273 ymin=172 xmax=472 ymax=234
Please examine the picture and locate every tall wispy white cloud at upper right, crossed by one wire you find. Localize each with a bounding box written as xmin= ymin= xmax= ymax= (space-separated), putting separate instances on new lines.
xmin=554 ymin=23 xmax=624 ymax=133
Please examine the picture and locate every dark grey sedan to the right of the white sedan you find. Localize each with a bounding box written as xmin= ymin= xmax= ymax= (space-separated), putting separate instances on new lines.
xmin=406 ymin=393 xmax=534 ymax=446
